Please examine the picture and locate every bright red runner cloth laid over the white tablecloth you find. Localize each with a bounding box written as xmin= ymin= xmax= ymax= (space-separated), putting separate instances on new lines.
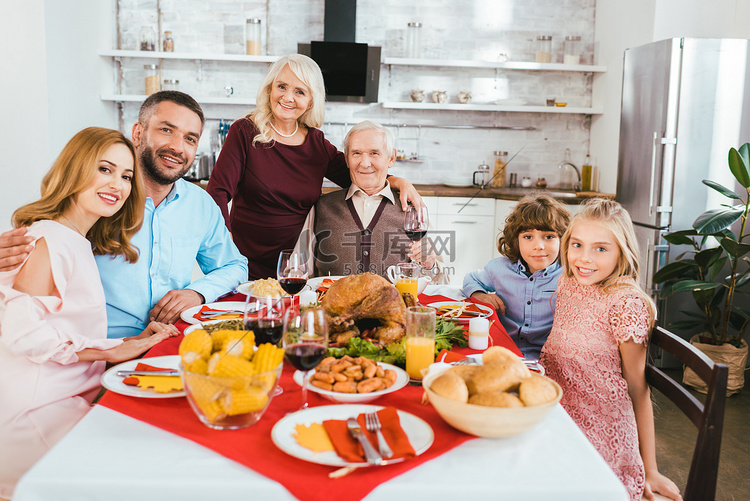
xmin=99 ymin=295 xmax=518 ymax=501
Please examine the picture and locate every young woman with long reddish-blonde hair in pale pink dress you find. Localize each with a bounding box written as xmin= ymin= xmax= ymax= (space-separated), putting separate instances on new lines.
xmin=0 ymin=127 xmax=177 ymax=498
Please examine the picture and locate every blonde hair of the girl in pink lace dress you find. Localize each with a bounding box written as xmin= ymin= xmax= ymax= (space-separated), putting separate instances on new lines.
xmin=560 ymin=198 xmax=656 ymax=327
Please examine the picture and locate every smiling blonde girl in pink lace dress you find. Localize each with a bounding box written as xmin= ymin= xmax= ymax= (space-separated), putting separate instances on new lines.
xmin=541 ymin=199 xmax=682 ymax=501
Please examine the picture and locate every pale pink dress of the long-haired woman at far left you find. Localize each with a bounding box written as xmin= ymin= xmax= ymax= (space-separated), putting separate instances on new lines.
xmin=0 ymin=221 xmax=122 ymax=498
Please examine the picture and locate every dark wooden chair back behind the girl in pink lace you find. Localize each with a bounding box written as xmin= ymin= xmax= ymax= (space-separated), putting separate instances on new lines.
xmin=646 ymin=327 xmax=728 ymax=501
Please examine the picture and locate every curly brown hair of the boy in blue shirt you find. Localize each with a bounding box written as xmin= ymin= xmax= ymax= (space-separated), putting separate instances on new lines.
xmin=497 ymin=192 xmax=570 ymax=262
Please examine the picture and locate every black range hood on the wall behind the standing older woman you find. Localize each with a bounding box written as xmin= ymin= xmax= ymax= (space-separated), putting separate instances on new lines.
xmin=297 ymin=0 xmax=381 ymax=103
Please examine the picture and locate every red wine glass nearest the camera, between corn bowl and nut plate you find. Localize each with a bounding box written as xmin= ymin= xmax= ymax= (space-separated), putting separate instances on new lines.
xmin=281 ymin=307 xmax=328 ymax=410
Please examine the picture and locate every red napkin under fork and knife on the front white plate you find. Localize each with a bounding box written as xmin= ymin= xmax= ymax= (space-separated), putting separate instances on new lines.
xmin=323 ymin=407 xmax=417 ymax=463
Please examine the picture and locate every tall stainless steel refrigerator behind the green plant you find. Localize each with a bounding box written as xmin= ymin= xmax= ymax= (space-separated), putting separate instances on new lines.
xmin=617 ymin=38 xmax=750 ymax=325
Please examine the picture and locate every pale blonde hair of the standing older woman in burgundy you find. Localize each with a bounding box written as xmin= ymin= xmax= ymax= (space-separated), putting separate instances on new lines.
xmin=246 ymin=54 xmax=326 ymax=145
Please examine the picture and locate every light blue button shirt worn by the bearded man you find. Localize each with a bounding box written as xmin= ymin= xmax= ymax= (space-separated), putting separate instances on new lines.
xmin=96 ymin=179 xmax=247 ymax=338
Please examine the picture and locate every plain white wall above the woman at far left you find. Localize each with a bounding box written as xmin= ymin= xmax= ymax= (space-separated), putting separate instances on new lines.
xmin=0 ymin=0 xmax=117 ymax=231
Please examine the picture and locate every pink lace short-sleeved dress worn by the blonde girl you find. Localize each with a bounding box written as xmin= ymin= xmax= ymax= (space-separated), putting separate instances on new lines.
xmin=540 ymin=277 xmax=649 ymax=501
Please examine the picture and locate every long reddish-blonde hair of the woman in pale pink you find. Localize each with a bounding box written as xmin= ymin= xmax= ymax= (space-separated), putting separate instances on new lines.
xmin=13 ymin=127 xmax=145 ymax=263
